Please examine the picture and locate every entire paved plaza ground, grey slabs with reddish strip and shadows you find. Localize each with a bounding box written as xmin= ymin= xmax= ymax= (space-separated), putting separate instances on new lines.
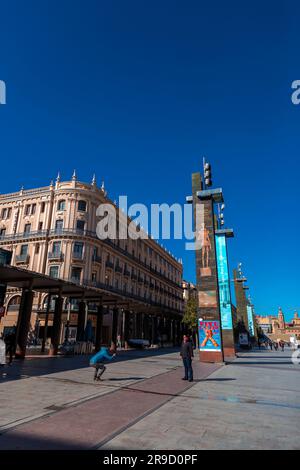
xmin=0 ymin=349 xmax=300 ymax=450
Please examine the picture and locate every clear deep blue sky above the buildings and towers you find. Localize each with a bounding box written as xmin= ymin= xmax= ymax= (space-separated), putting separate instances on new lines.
xmin=0 ymin=0 xmax=300 ymax=322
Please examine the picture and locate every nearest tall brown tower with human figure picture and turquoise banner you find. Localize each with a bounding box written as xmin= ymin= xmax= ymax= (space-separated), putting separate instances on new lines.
xmin=187 ymin=167 xmax=235 ymax=362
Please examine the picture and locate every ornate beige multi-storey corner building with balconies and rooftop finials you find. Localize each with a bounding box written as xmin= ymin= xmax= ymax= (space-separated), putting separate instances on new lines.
xmin=0 ymin=172 xmax=183 ymax=343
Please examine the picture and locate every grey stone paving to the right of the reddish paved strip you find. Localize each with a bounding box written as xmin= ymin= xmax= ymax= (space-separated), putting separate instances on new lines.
xmin=101 ymin=350 xmax=300 ymax=450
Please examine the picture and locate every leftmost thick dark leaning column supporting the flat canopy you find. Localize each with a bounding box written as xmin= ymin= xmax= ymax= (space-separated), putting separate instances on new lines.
xmin=16 ymin=289 xmax=34 ymax=359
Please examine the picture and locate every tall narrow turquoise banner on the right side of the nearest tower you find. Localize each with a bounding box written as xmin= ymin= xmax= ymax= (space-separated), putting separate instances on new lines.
xmin=216 ymin=235 xmax=233 ymax=330
